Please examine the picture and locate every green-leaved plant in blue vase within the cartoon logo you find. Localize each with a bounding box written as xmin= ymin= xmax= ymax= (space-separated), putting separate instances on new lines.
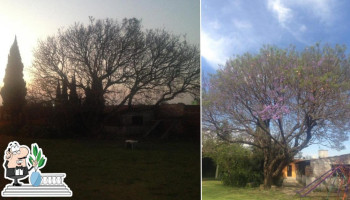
xmin=29 ymin=144 xmax=47 ymax=187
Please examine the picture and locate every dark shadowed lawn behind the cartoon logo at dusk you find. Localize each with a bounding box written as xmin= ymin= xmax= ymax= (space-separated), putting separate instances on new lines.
xmin=0 ymin=135 xmax=200 ymax=200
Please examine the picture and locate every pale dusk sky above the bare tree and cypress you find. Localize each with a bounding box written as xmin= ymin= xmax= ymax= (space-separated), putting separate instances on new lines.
xmin=0 ymin=0 xmax=200 ymax=104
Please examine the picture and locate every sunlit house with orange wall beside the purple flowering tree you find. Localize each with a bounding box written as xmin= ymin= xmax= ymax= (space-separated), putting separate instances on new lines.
xmin=283 ymin=150 xmax=350 ymax=186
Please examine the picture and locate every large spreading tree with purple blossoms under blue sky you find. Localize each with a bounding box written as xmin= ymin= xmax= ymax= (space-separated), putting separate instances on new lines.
xmin=203 ymin=44 xmax=350 ymax=188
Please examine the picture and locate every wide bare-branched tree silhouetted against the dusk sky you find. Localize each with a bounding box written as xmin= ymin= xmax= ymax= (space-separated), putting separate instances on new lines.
xmin=32 ymin=18 xmax=200 ymax=130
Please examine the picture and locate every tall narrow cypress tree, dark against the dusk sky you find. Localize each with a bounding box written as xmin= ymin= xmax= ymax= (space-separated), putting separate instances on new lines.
xmin=0 ymin=37 xmax=27 ymax=118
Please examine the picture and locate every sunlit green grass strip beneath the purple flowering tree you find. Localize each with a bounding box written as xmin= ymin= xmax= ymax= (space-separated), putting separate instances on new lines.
xmin=202 ymin=180 xmax=325 ymax=200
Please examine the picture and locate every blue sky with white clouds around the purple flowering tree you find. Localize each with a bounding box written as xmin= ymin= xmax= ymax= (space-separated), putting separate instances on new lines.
xmin=201 ymin=0 xmax=350 ymax=159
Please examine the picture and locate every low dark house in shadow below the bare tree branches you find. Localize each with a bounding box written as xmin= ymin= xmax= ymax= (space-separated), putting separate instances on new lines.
xmin=104 ymin=104 xmax=200 ymax=141
